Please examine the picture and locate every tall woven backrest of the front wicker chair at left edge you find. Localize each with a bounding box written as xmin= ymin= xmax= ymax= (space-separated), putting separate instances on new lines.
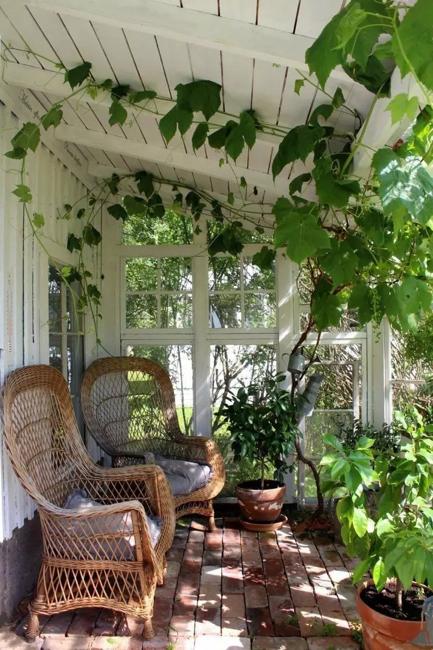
xmin=4 ymin=365 xmax=87 ymax=506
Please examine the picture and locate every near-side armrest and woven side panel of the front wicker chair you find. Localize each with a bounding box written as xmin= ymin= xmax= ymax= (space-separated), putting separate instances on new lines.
xmin=39 ymin=501 xmax=157 ymax=568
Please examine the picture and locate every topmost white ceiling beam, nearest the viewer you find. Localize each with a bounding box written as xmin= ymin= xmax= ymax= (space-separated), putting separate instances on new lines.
xmin=22 ymin=0 xmax=347 ymax=79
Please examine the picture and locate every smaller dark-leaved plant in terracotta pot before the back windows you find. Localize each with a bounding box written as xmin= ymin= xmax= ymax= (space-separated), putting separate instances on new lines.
xmin=223 ymin=374 xmax=297 ymax=530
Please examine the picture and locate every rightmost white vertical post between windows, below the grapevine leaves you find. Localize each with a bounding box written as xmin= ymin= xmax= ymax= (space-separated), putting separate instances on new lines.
xmin=369 ymin=319 xmax=392 ymax=427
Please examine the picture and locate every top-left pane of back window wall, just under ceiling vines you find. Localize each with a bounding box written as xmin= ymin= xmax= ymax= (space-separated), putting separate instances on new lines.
xmin=123 ymin=210 xmax=193 ymax=245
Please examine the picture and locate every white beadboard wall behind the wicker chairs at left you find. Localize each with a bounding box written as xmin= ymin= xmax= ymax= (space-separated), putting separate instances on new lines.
xmin=0 ymin=86 xmax=95 ymax=542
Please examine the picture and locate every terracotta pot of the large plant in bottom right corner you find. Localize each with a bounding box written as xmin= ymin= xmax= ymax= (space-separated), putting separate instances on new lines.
xmin=356 ymin=580 xmax=422 ymax=650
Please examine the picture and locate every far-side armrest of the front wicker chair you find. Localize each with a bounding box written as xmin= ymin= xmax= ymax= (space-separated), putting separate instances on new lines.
xmin=86 ymin=465 xmax=176 ymax=548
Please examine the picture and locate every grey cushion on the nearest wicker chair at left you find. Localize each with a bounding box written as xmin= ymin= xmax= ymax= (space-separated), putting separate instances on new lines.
xmin=63 ymin=488 xmax=162 ymax=547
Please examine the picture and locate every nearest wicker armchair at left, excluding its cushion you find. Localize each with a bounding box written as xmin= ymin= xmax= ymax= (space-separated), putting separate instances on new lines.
xmin=4 ymin=365 xmax=175 ymax=639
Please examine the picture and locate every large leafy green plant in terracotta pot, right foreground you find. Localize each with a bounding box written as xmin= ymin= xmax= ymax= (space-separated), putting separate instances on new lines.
xmin=321 ymin=408 xmax=433 ymax=650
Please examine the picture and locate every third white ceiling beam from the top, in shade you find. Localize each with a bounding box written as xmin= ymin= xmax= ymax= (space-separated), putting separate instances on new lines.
xmin=55 ymin=126 xmax=288 ymax=194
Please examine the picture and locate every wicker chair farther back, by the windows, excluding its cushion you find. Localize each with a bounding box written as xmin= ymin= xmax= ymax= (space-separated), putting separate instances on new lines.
xmin=81 ymin=357 xmax=225 ymax=530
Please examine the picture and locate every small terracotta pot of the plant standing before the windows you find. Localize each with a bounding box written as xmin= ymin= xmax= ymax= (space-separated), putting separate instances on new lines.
xmin=236 ymin=481 xmax=286 ymax=523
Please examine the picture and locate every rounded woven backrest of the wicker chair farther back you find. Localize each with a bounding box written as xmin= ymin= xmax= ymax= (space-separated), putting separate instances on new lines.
xmin=81 ymin=357 xmax=179 ymax=455
